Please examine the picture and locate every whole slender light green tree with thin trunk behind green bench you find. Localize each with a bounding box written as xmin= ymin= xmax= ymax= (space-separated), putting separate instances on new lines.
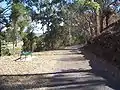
xmin=10 ymin=0 xmax=28 ymax=50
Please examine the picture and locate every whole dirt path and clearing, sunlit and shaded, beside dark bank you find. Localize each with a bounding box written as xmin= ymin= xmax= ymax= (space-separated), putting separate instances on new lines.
xmin=0 ymin=46 xmax=119 ymax=90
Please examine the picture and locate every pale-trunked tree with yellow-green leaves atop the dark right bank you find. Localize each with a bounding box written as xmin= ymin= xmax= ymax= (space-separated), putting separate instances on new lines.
xmin=77 ymin=0 xmax=120 ymax=36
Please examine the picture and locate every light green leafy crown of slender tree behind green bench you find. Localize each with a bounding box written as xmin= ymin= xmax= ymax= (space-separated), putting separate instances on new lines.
xmin=11 ymin=3 xmax=29 ymax=29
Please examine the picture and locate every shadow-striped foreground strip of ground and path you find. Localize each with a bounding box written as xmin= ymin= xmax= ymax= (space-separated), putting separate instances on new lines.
xmin=0 ymin=69 xmax=107 ymax=90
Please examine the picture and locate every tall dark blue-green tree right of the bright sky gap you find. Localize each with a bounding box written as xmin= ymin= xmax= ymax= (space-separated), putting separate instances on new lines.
xmin=30 ymin=0 xmax=69 ymax=49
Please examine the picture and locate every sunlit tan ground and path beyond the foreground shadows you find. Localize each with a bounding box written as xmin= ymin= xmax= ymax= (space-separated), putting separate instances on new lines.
xmin=0 ymin=47 xmax=90 ymax=75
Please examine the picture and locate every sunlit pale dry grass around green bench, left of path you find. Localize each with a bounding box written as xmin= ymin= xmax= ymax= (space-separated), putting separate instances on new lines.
xmin=0 ymin=51 xmax=56 ymax=74
